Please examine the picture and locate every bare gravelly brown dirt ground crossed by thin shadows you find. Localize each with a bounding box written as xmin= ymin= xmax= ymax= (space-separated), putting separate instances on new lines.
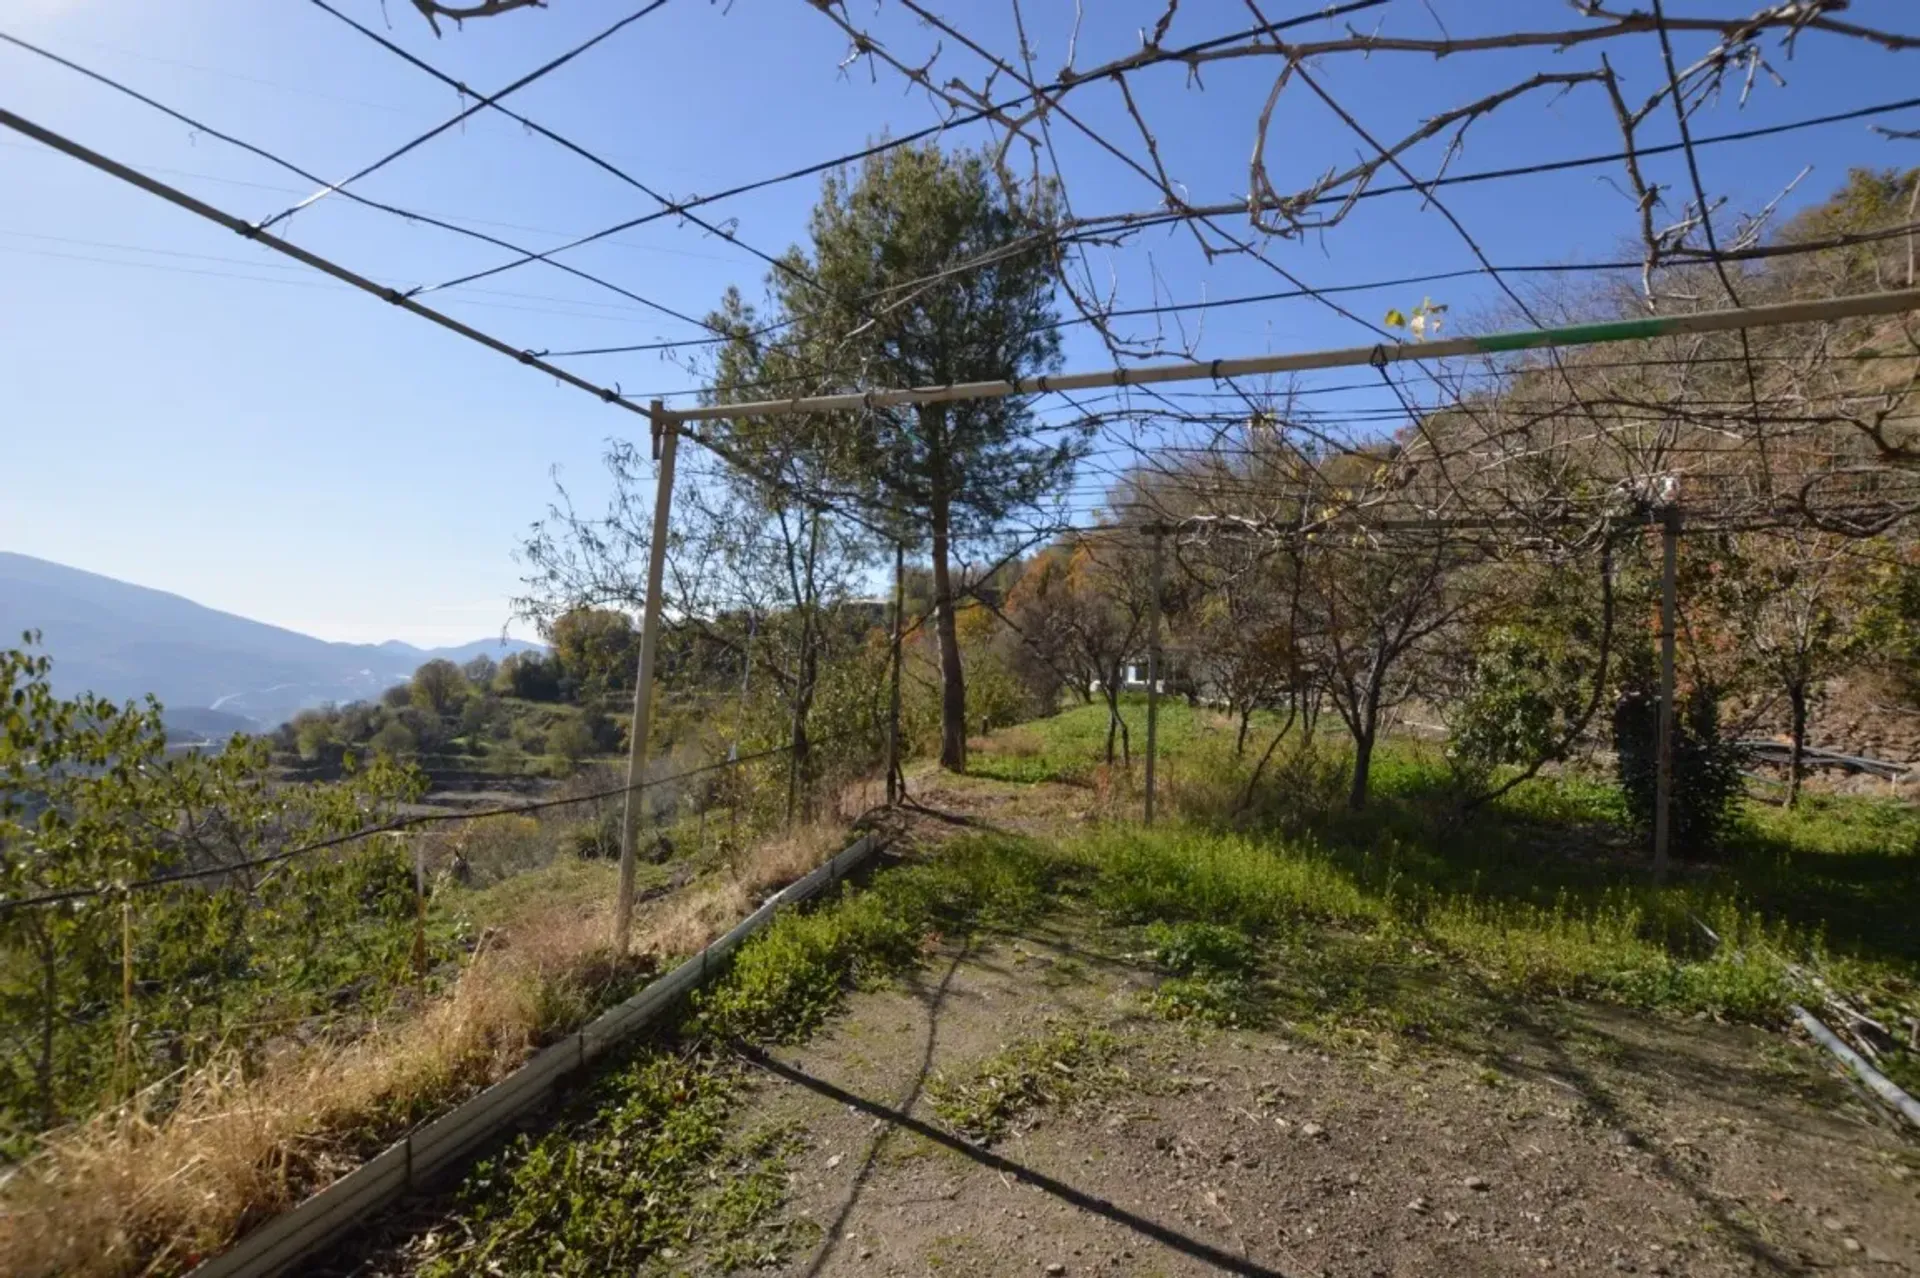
xmin=721 ymin=781 xmax=1920 ymax=1278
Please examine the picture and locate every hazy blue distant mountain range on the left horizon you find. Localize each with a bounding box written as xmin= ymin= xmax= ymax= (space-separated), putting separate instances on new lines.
xmin=0 ymin=551 xmax=540 ymax=737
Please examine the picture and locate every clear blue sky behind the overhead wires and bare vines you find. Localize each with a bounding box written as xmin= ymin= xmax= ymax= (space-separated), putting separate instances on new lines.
xmin=0 ymin=0 xmax=1920 ymax=637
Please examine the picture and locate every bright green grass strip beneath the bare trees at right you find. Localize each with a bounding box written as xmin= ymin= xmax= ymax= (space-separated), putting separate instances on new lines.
xmin=979 ymin=700 xmax=1920 ymax=1071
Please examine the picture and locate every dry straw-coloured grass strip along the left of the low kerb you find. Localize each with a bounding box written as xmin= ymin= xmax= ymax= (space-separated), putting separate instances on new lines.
xmin=0 ymin=825 xmax=843 ymax=1278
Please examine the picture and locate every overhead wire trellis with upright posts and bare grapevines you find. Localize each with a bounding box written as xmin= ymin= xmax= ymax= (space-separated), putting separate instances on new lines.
xmin=0 ymin=0 xmax=1920 ymax=946
